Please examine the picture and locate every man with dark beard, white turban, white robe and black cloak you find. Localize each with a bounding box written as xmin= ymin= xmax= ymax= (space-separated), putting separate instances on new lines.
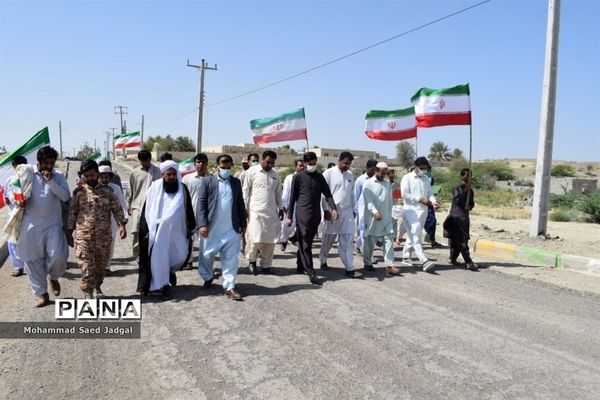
xmin=137 ymin=160 xmax=196 ymax=297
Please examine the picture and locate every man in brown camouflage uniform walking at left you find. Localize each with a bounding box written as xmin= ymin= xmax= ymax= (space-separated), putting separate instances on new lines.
xmin=67 ymin=160 xmax=127 ymax=299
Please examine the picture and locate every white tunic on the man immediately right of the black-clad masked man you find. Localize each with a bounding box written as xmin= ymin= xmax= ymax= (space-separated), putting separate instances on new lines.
xmin=321 ymin=166 xmax=355 ymax=235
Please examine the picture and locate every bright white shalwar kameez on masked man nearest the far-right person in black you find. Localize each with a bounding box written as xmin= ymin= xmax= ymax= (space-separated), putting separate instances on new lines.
xmin=400 ymin=171 xmax=437 ymax=263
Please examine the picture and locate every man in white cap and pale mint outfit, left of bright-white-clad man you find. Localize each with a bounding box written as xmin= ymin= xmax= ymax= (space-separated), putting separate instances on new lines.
xmin=362 ymin=162 xmax=400 ymax=275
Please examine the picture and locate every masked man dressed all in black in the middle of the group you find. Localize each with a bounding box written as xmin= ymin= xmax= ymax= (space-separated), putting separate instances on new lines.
xmin=288 ymin=151 xmax=338 ymax=285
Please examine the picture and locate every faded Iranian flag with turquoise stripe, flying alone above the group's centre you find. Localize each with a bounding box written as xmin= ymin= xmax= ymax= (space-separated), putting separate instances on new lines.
xmin=250 ymin=108 xmax=308 ymax=144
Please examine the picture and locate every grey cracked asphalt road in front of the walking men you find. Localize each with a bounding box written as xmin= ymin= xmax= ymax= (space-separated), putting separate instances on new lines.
xmin=0 ymin=161 xmax=600 ymax=399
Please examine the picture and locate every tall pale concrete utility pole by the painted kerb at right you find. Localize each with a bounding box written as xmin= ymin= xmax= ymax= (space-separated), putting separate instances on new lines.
xmin=529 ymin=0 xmax=560 ymax=237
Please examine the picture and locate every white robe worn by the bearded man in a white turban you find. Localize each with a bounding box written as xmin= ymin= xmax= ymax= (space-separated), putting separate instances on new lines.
xmin=144 ymin=179 xmax=189 ymax=290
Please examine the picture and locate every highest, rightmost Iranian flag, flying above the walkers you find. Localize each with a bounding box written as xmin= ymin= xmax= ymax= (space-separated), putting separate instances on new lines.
xmin=411 ymin=83 xmax=471 ymax=128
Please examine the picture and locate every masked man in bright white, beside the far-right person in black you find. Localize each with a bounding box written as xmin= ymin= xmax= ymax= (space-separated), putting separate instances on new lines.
xmin=400 ymin=157 xmax=440 ymax=272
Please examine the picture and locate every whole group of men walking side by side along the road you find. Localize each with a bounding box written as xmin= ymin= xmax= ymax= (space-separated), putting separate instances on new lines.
xmin=2 ymin=146 xmax=476 ymax=306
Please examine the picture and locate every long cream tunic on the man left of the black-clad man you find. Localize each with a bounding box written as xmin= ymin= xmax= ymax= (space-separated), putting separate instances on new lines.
xmin=242 ymin=165 xmax=283 ymax=243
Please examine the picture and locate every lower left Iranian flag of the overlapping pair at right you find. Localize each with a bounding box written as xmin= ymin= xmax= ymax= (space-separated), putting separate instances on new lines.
xmin=365 ymin=107 xmax=417 ymax=140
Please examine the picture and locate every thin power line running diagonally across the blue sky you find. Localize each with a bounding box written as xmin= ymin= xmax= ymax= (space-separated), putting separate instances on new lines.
xmin=152 ymin=0 xmax=492 ymax=128
